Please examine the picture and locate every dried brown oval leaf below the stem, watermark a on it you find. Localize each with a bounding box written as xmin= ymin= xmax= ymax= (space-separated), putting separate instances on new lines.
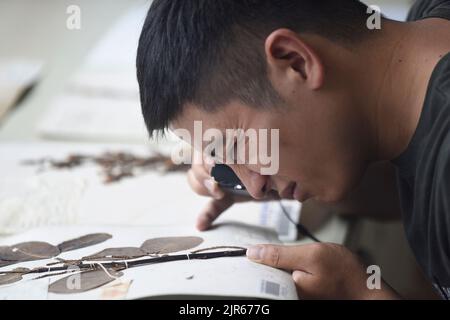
xmin=48 ymin=270 xmax=123 ymax=294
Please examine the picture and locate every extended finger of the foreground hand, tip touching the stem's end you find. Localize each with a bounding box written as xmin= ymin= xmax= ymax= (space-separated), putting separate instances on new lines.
xmin=247 ymin=245 xmax=317 ymax=273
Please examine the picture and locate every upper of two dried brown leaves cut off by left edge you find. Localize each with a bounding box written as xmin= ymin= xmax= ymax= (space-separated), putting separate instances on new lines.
xmin=0 ymin=241 xmax=60 ymax=262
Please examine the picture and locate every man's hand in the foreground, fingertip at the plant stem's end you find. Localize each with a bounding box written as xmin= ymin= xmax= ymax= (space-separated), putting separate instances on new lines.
xmin=247 ymin=243 xmax=399 ymax=300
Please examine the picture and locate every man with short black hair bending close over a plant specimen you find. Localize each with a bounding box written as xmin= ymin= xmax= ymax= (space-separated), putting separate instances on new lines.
xmin=137 ymin=0 xmax=450 ymax=299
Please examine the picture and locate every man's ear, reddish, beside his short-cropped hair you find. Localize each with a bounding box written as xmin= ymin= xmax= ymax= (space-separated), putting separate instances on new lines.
xmin=265 ymin=29 xmax=324 ymax=90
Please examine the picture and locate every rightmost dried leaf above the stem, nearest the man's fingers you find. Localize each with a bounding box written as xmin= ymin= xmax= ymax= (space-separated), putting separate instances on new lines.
xmin=141 ymin=237 xmax=203 ymax=254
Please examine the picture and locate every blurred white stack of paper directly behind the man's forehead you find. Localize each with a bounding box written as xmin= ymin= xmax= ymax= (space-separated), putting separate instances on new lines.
xmin=38 ymin=4 xmax=155 ymax=143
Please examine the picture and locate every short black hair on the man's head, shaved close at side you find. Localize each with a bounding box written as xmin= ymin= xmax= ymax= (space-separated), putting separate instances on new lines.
xmin=137 ymin=0 xmax=368 ymax=135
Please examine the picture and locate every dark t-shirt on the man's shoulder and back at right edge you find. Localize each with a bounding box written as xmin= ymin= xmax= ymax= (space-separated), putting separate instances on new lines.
xmin=393 ymin=0 xmax=450 ymax=299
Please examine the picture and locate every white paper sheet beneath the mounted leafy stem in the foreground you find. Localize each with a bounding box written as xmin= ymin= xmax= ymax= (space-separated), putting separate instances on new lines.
xmin=0 ymin=223 xmax=297 ymax=299
